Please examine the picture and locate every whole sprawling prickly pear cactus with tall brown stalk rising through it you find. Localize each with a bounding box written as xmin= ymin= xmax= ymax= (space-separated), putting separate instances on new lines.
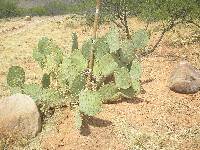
xmin=5 ymin=1 xmax=148 ymax=128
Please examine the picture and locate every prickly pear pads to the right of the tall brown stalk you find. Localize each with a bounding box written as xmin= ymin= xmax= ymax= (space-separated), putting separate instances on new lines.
xmin=85 ymin=28 xmax=148 ymax=101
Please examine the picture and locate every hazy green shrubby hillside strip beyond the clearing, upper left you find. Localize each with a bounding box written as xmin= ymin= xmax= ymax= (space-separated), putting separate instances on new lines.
xmin=0 ymin=0 xmax=95 ymax=18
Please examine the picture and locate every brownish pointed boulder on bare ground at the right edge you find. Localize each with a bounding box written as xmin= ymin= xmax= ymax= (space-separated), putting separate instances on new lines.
xmin=169 ymin=60 xmax=200 ymax=94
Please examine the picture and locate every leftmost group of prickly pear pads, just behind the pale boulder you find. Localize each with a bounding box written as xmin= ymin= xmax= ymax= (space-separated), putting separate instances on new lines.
xmin=7 ymin=38 xmax=63 ymax=116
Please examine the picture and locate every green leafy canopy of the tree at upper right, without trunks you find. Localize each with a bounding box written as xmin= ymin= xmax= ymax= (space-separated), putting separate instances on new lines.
xmin=102 ymin=0 xmax=200 ymax=21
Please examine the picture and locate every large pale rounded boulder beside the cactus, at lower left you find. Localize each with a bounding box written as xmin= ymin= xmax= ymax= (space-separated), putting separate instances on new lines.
xmin=0 ymin=94 xmax=41 ymax=140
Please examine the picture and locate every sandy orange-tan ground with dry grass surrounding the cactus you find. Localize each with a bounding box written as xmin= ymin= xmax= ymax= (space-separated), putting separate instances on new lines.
xmin=0 ymin=16 xmax=200 ymax=150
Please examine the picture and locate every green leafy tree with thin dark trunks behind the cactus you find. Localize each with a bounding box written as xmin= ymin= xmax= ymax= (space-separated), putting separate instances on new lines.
xmin=102 ymin=0 xmax=200 ymax=52
